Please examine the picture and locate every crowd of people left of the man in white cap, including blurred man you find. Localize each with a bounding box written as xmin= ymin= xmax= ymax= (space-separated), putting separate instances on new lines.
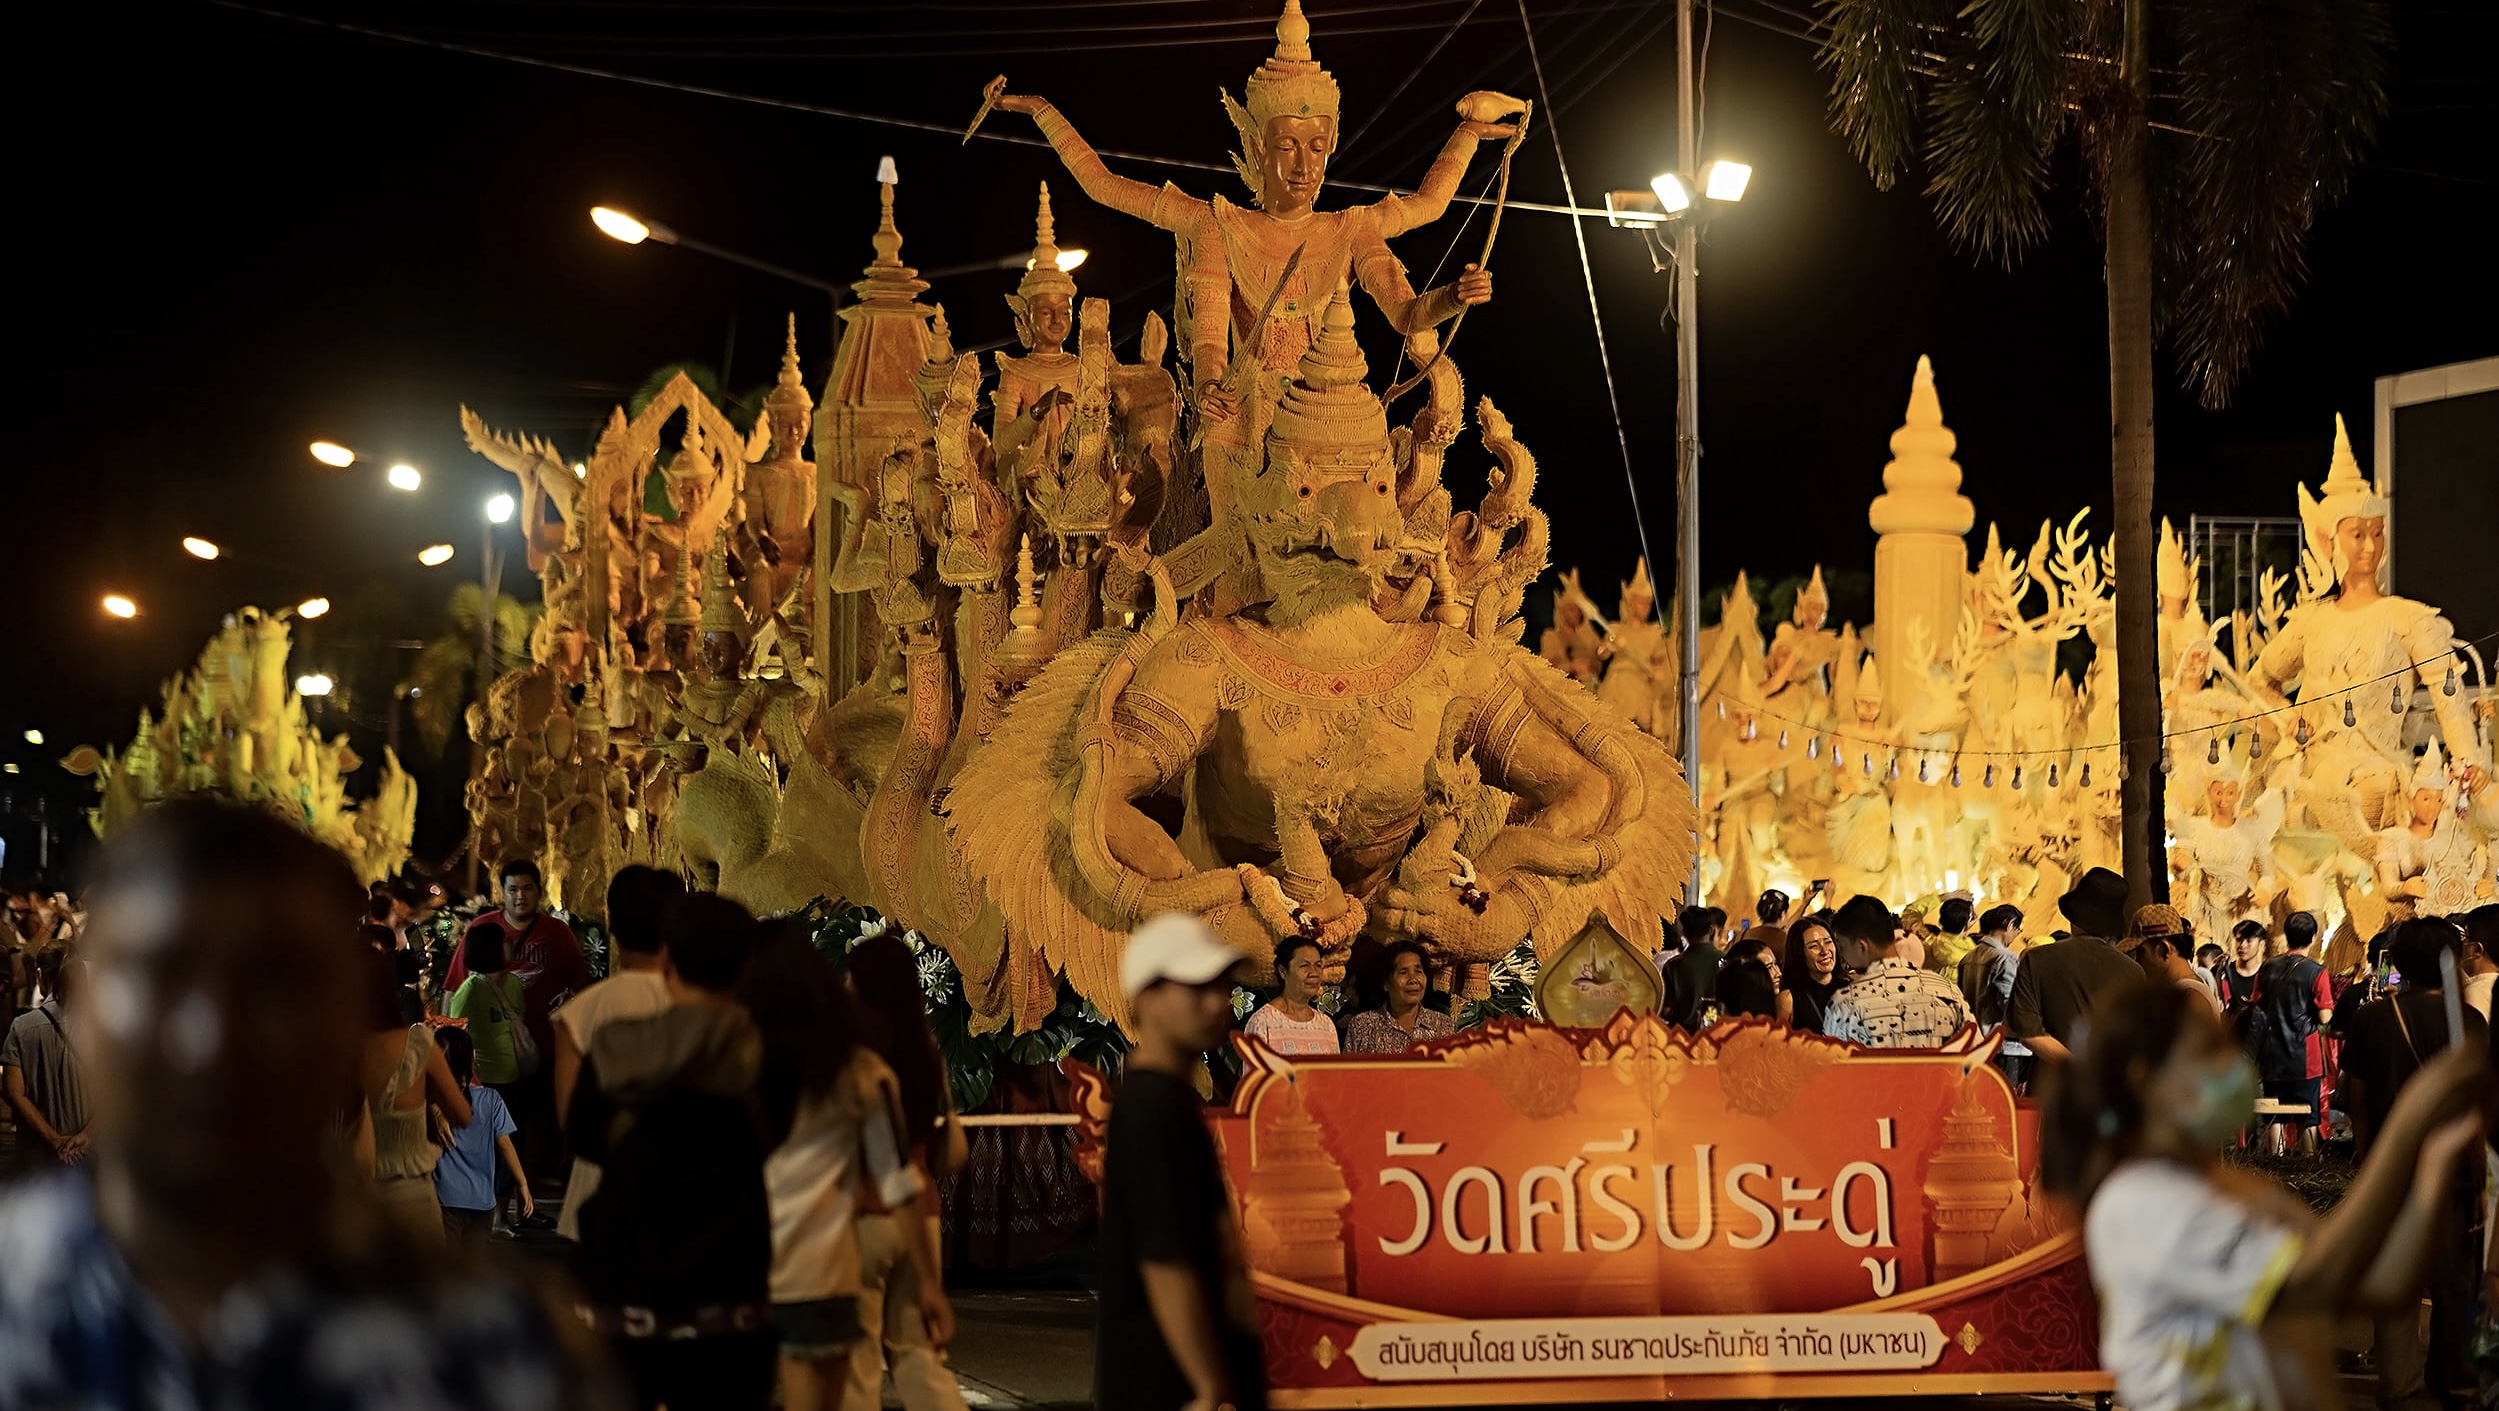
xmin=0 ymin=799 xmax=965 ymax=1411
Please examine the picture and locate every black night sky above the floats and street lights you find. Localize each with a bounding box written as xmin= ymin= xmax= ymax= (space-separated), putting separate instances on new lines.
xmin=0 ymin=0 xmax=2499 ymax=862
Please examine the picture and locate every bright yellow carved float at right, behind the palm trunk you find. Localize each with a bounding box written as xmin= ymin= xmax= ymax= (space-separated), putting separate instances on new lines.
xmin=1549 ymin=360 xmax=2499 ymax=937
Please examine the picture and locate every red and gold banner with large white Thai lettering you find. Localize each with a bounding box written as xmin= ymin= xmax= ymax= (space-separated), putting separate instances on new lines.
xmin=1084 ymin=1014 xmax=2112 ymax=1406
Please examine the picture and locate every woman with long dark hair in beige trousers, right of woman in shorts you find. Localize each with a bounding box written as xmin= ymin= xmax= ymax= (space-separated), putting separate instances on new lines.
xmin=845 ymin=932 xmax=965 ymax=1411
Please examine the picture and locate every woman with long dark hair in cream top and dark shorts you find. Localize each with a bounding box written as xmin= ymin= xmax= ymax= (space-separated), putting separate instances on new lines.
xmin=737 ymin=922 xmax=955 ymax=1411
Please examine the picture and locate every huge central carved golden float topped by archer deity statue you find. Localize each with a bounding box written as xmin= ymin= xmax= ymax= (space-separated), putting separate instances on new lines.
xmin=467 ymin=5 xmax=1694 ymax=1026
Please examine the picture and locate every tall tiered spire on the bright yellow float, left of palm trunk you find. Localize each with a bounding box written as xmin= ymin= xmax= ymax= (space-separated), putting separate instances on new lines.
xmin=1867 ymin=355 xmax=1977 ymax=699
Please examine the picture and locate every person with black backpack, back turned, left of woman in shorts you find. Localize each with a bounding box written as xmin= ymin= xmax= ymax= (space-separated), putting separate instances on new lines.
xmin=567 ymin=892 xmax=780 ymax=1411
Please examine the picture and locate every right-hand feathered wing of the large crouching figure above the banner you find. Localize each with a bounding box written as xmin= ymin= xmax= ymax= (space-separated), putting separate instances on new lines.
xmin=1512 ymin=649 xmax=1694 ymax=959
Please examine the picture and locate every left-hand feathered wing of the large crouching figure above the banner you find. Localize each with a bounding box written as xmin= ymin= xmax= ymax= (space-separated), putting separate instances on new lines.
xmin=947 ymin=632 xmax=1130 ymax=1026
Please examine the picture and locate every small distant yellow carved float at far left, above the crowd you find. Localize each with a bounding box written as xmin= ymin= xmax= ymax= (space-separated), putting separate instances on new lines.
xmin=62 ymin=607 xmax=417 ymax=882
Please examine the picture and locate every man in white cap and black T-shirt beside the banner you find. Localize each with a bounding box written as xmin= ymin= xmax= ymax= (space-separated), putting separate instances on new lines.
xmin=1095 ymin=914 xmax=1267 ymax=1411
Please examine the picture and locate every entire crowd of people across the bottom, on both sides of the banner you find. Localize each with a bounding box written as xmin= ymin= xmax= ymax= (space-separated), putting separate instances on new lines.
xmin=0 ymin=799 xmax=2499 ymax=1411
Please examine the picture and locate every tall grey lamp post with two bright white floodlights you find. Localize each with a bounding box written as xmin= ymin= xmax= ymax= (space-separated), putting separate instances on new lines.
xmin=1604 ymin=0 xmax=1752 ymax=904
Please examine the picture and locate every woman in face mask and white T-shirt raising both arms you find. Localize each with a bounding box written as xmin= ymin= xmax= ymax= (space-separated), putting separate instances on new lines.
xmin=2039 ymin=981 xmax=2489 ymax=1411
